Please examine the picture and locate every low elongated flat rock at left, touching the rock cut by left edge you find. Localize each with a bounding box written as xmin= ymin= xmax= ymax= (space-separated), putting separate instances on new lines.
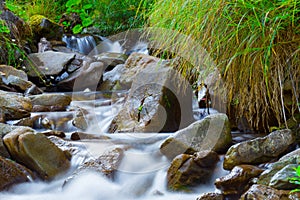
xmin=29 ymin=94 xmax=72 ymax=107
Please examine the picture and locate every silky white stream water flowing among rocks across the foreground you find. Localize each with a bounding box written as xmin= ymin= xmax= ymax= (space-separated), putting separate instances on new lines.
xmin=0 ymin=91 xmax=226 ymax=200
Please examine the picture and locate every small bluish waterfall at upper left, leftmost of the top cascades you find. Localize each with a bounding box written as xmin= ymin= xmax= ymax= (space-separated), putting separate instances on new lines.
xmin=62 ymin=35 xmax=97 ymax=55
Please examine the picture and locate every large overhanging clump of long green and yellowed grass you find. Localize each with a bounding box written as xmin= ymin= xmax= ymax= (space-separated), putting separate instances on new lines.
xmin=149 ymin=0 xmax=300 ymax=130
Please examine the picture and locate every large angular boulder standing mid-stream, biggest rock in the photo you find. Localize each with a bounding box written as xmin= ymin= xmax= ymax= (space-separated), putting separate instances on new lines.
xmin=109 ymin=57 xmax=194 ymax=133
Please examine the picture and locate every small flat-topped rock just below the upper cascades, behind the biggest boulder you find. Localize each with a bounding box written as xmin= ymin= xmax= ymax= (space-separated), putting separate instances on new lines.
xmin=93 ymin=52 xmax=128 ymax=71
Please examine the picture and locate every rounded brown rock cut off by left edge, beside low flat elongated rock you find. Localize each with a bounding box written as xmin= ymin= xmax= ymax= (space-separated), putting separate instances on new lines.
xmin=0 ymin=90 xmax=32 ymax=120
